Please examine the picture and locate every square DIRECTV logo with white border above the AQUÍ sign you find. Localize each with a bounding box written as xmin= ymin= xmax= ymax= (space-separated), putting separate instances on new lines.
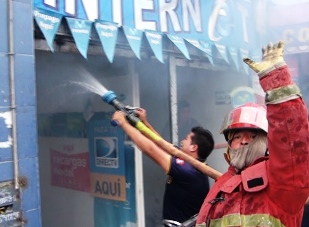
xmin=94 ymin=137 xmax=119 ymax=168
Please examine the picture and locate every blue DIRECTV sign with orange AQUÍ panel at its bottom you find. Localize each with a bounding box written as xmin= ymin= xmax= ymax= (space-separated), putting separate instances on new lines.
xmin=88 ymin=120 xmax=126 ymax=201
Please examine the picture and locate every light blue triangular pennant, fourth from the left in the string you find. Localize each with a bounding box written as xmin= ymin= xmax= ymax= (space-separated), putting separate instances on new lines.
xmin=123 ymin=26 xmax=143 ymax=59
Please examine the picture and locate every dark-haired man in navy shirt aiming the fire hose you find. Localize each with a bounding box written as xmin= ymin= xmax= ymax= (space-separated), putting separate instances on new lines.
xmin=112 ymin=108 xmax=214 ymax=226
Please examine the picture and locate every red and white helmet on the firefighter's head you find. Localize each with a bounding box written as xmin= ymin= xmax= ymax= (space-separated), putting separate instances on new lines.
xmin=220 ymin=102 xmax=268 ymax=141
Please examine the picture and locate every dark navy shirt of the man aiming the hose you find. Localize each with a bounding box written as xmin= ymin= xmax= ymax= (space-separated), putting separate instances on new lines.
xmin=163 ymin=152 xmax=209 ymax=222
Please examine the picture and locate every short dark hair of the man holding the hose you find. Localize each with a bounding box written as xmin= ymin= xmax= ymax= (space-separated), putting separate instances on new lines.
xmin=191 ymin=126 xmax=215 ymax=161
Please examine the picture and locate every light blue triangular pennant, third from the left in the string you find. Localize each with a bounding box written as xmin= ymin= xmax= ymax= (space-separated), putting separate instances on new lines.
xmin=94 ymin=20 xmax=118 ymax=63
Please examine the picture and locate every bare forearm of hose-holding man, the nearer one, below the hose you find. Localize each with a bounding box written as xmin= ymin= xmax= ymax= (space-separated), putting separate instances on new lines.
xmin=112 ymin=111 xmax=172 ymax=173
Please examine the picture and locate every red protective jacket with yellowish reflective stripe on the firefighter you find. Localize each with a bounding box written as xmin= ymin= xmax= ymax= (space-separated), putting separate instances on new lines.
xmin=196 ymin=66 xmax=309 ymax=227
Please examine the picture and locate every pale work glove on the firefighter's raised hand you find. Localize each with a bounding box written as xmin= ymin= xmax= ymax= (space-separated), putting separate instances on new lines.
xmin=243 ymin=41 xmax=286 ymax=79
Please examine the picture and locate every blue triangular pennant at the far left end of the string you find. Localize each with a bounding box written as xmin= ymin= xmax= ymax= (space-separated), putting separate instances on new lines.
xmin=33 ymin=8 xmax=63 ymax=52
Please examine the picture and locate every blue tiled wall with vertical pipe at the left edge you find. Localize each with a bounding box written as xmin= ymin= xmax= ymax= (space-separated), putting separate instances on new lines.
xmin=0 ymin=0 xmax=41 ymax=227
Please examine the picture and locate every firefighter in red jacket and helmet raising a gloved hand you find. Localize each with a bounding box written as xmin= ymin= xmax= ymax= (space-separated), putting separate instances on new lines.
xmin=196 ymin=41 xmax=309 ymax=227
